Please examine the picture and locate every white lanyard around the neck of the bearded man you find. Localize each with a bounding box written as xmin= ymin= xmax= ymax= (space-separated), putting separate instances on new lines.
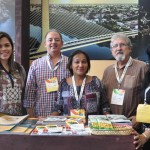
xmin=115 ymin=57 xmax=132 ymax=88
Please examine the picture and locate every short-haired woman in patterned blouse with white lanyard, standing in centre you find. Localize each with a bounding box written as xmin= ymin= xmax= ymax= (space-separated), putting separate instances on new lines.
xmin=54 ymin=50 xmax=109 ymax=116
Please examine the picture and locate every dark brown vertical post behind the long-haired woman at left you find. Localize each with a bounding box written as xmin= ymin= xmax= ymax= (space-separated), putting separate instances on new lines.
xmin=15 ymin=0 xmax=30 ymax=71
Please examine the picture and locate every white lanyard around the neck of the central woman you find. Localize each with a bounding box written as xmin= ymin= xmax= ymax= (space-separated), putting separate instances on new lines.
xmin=72 ymin=76 xmax=86 ymax=101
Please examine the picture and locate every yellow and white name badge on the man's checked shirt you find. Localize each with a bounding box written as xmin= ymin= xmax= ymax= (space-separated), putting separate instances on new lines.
xmin=45 ymin=77 xmax=58 ymax=92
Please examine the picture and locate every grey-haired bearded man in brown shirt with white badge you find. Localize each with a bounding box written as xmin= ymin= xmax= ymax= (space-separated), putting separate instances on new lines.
xmin=102 ymin=33 xmax=147 ymax=131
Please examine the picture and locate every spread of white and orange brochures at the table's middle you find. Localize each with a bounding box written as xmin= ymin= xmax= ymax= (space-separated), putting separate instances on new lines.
xmin=31 ymin=116 xmax=91 ymax=135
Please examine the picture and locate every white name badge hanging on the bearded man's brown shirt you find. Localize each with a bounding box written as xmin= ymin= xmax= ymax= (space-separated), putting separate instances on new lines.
xmin=111 ymin=89 xmax=125 ymax=105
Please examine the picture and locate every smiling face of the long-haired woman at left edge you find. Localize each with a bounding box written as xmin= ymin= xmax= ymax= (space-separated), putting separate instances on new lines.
xmin=0 ymin=37 xmax=12 ymax=62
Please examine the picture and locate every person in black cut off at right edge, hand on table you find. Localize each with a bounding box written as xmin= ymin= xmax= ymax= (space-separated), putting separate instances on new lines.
xmin=134 ymin=45 xmax=150 ymax=150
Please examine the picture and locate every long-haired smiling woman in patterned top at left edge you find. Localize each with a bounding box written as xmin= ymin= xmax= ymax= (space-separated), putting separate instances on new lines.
xmin=0 ymin=32 xmax=25 ymax=115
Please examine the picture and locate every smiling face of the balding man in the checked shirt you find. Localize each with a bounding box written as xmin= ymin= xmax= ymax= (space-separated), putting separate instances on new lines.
xmin=44 ymin=32 xmax=63 ymax=54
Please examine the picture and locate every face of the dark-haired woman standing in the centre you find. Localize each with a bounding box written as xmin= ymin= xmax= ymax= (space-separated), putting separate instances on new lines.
xmin=71 ymin=53 xmax=89 ymax=76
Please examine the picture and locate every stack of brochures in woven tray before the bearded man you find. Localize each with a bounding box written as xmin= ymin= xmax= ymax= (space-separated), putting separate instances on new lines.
xmin=88 ymin=114 xmax=132 ymax=135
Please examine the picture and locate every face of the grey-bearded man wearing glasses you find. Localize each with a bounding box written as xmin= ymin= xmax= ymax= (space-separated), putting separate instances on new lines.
xmin=111 ymin=38 xmax=131 ymax=61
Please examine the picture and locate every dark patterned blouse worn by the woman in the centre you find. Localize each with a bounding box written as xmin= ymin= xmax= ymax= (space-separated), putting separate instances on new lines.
xmin=55 ymin=76 xmax=109 ymax=115
